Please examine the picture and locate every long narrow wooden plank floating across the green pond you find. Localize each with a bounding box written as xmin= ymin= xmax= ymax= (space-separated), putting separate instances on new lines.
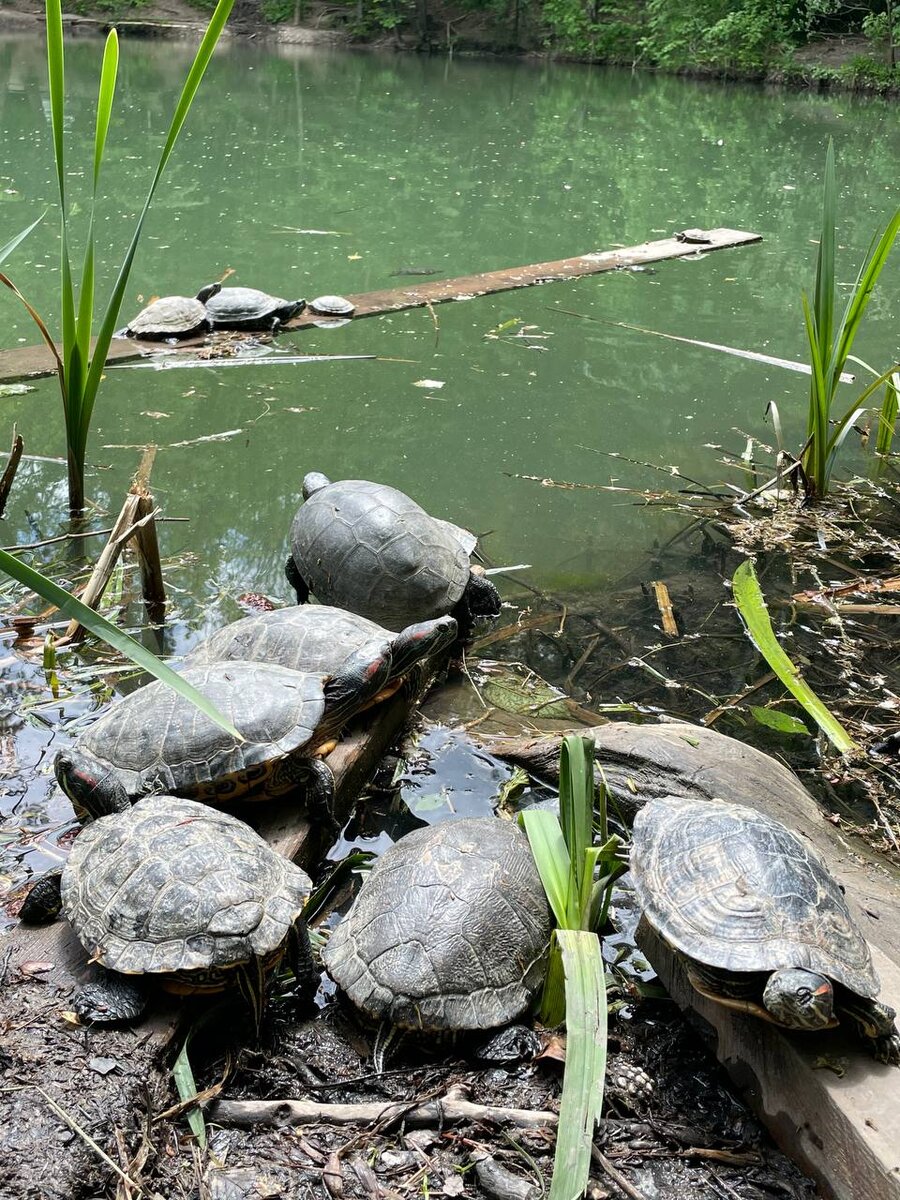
xmin=0 ymin=229 xmax=762 ymax=383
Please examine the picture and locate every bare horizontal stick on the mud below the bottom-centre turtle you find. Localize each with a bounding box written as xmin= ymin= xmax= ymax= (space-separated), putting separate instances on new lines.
xmin=209 ymin=1098 xmax=558 ymax=1129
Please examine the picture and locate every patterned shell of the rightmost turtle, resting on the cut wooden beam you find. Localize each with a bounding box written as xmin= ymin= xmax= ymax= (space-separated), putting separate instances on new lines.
xmin=631 ymin=797 xmax=878 ymax=998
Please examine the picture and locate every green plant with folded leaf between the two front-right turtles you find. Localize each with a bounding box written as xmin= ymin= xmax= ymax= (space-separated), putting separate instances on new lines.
xmin=520 ymin=736 xmax=625 ymax=1200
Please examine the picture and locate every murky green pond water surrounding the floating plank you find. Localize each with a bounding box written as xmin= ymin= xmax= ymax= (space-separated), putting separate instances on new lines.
xmin=0 ymin=37 xmax=900 ymax=902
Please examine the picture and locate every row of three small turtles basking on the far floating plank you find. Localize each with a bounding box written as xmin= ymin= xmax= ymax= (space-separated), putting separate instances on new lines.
xmin=122 ymin=283 xmax=355 ymax=342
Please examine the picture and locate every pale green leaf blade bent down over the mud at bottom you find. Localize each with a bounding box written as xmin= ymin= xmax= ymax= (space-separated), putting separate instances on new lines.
xmin=550 ymin=929 xmax=606 ymax=1200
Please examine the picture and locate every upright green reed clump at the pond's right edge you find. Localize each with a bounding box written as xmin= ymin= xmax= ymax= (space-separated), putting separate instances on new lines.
xmin=802 ymin=138 xmax=900 ymax=499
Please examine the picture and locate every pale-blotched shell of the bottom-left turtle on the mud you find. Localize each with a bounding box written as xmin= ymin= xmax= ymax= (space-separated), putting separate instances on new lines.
xmin=62 ymin=796 xmax=312 ymax=974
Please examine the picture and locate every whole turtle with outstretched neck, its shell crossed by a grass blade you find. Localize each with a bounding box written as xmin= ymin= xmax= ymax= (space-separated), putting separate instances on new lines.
xmin=53 ymin=642 xmax=391 ymax=832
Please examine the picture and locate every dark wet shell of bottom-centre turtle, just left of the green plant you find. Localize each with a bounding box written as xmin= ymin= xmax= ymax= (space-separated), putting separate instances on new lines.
xmin=323 ymin=817 xmax=552 ymax=1032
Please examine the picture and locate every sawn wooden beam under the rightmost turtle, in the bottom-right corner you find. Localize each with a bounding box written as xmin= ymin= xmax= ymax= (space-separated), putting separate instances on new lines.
xmin=637 ymin=924 xmax=900 ymax=1200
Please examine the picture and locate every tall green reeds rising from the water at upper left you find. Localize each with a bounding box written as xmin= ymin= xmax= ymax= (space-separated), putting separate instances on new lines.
xmin=0 ymin=0 xmax=234 ymax=515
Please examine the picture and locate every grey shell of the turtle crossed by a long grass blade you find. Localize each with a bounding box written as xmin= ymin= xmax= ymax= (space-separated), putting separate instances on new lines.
xmin=69 ymin=662 xmax=325 ymax=798
